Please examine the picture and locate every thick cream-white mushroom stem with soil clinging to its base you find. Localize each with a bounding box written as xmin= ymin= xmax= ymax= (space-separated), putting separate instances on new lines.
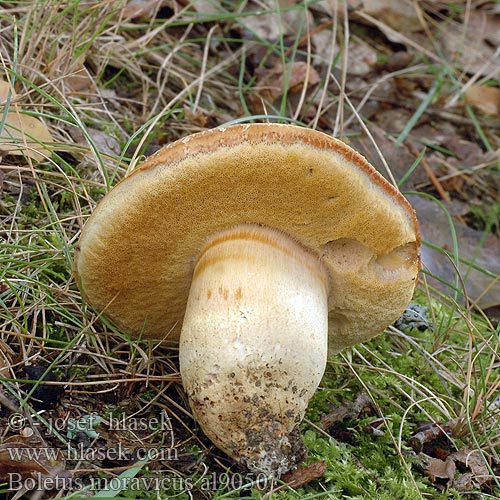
xmin=179 ymin=225 xmax=328 ymax=475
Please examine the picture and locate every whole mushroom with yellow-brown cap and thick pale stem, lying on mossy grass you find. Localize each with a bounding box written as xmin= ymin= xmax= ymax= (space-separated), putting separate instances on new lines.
xmin=75 ymin=124 xmax=420 ymax=475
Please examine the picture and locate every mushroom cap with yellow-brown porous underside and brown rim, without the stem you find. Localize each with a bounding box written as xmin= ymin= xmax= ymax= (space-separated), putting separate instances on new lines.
xmin=75 ymin=124 xmax=420 ymax=353
